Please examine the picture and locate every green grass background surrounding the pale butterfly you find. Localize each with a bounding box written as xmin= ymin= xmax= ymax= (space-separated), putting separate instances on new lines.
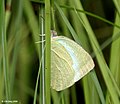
xmin=0 ymin=0 xmax=120 ymax=104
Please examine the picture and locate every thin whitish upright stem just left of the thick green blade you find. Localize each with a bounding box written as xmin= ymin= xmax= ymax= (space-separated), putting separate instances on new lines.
xmin=39 ymin=4 xmax=45 ymax=104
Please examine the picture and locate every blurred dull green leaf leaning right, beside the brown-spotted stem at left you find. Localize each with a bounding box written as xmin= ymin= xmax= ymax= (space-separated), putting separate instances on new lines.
xmin=10 ymin=1 xmax=22 ymax=93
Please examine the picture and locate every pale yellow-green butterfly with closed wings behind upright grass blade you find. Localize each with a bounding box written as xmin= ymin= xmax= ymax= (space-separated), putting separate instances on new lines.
xmin=51 ymin=36 xmax=95 ymax=91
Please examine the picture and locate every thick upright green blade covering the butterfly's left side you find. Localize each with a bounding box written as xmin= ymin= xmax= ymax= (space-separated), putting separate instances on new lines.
xmin=45 ymin=0 xmax=51 ymax=104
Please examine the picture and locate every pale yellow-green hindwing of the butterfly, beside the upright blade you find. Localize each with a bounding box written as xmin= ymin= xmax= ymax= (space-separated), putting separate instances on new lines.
xmin=51 ymin=40 xmax=75 ymax=91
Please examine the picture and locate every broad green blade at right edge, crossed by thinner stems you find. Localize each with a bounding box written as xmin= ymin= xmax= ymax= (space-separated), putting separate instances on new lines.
xmin=106 ymin=13 xmax=120 ymax=104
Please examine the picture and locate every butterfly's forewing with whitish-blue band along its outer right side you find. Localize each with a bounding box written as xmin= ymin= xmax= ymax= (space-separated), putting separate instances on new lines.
xmin=53 ymin=36 xmax=94 ymax=82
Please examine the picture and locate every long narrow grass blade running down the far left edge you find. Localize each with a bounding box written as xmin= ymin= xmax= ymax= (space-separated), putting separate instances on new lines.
xmin=0 ymin=0 xmax=11 ymax=100
